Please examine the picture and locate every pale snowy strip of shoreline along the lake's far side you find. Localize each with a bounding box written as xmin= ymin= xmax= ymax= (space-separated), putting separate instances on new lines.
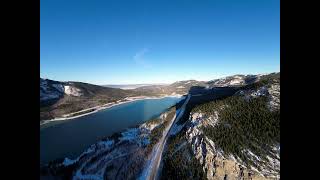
xmin=40 ymin=94 xmax=183 ymax=127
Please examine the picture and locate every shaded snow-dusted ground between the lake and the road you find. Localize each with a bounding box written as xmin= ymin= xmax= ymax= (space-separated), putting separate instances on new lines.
xmin=42 ymin=108 xmax=176 ymax=180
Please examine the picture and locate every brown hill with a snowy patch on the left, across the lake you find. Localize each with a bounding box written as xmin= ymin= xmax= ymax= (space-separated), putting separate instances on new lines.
xmin=40 ymin=78 xmax=140 ymax=120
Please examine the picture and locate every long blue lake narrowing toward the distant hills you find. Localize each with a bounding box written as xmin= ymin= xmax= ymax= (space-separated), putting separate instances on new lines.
xmin=40 ymin=97 xmax=182 ymax=164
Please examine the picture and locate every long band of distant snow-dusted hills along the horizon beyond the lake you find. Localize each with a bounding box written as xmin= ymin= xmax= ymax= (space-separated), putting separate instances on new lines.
xmin=40 ymin=75 xmax=278 ymax=120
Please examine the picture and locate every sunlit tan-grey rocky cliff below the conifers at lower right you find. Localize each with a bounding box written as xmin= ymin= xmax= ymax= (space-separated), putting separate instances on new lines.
xmin=185 ymin=113 xmax=280 ymax=180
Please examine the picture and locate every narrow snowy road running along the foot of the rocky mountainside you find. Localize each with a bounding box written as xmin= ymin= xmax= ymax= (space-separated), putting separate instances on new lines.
xmin=141 ymin=94 xmax=191 ymax=180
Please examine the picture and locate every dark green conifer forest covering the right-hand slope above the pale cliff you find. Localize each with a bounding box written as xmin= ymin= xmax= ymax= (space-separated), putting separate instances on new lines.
xmin=193 ymin=96 xmax=280 ymax=165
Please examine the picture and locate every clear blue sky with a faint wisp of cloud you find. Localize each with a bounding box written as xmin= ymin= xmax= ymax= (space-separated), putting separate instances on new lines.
xmin=40 ymin=0 xmax=280 ymax=84
